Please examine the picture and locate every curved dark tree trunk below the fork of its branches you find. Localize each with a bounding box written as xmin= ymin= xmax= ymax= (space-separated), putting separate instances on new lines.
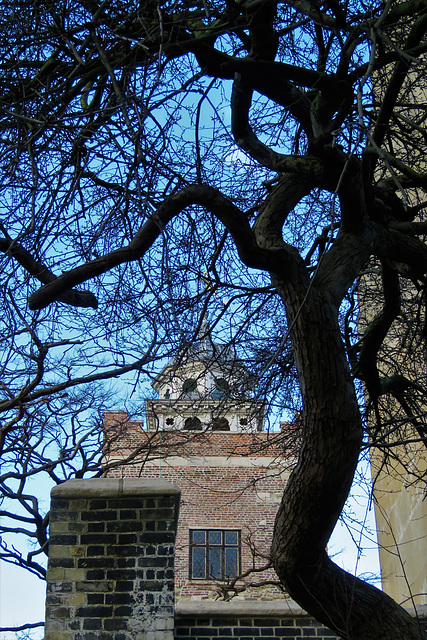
xmin=271 ymin=271 xmax=425 ymax=640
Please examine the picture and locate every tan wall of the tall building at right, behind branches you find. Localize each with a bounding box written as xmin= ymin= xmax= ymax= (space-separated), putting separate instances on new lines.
xmin=368 ymin=20 xmax=427 ymax=607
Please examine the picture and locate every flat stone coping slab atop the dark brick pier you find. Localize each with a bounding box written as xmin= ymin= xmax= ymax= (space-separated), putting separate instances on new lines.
xmin=50 ymin=478 xmax=181 ymax=498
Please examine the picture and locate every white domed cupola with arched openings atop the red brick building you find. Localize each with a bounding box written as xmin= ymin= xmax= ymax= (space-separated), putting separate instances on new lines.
xmin=146 ymin=330 xmax=264 ymax=432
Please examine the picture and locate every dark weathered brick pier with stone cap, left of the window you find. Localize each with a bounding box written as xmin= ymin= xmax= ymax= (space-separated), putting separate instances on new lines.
xmin=45 ymin=478 xmax=180 ymax=640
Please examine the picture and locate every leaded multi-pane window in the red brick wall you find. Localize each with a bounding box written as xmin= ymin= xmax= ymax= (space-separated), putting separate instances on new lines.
xmin=190 ymin=529 xmax=241 ymax=580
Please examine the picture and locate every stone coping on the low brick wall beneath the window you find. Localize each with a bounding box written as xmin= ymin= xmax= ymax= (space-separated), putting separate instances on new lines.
xmin=175 ymin=599 xmax=308 ymax=618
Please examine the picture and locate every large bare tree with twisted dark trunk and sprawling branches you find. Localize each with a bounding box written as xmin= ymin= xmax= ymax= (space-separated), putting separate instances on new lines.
xmin=0 ymin=0 xmax=427 ymax=640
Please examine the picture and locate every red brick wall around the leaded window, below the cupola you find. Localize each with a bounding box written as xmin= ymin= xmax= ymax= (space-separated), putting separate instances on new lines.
xmin=105 ymin=412 xmax=298 ymax=599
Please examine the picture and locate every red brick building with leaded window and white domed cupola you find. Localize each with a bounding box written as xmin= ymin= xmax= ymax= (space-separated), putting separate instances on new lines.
xmin=104 ymin=338 xmax=293 ymax=602
